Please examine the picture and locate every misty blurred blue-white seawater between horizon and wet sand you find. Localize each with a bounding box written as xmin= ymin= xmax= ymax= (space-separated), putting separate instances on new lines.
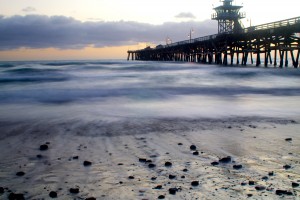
xmin=0 ymin=60 xmax=300 ymax=121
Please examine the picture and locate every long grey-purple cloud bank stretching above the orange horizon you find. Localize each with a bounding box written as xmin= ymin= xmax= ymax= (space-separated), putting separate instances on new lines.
xmin=0 ymin=15 xmax=217 ymax=50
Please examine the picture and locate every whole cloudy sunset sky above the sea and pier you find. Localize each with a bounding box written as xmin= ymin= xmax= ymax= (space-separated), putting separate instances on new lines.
xmin=0 ymin=0 xmax=300 ymax=61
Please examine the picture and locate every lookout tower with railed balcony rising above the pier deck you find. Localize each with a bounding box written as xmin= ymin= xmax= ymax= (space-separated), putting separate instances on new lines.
xmin=211 ymin=0 xmax=246 ymax=34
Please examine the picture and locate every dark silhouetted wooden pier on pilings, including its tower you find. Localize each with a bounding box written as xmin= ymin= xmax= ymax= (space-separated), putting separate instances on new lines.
xmin=127 ymin=0 xmax=300 ymax=68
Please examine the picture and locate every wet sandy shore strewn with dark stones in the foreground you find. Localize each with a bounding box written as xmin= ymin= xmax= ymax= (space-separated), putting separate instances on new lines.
xmin=0 ymin=117 xmax=300 ymax=199
